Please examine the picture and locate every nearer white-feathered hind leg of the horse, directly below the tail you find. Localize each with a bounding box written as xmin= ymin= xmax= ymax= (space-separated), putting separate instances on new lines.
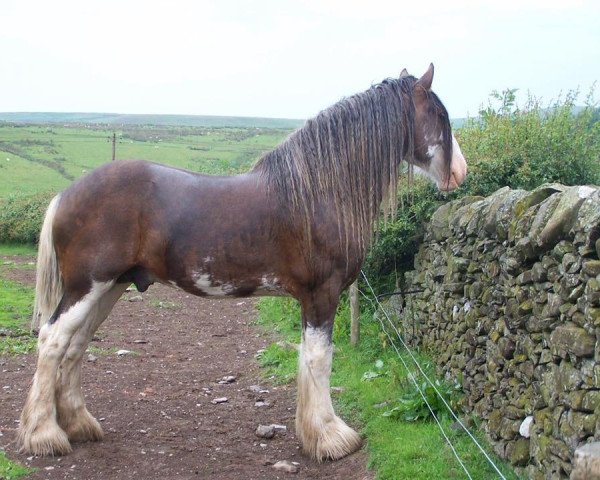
xmin=17 ymin=282 xmax=113 ymax=455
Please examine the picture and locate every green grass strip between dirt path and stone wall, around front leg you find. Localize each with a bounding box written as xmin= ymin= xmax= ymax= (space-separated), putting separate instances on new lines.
xmin=258 ymin=298 xmax=519 ymax=480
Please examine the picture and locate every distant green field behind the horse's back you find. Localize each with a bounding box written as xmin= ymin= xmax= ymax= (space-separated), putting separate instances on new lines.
xmin=0 ymin=124 xmax=291 ymax=198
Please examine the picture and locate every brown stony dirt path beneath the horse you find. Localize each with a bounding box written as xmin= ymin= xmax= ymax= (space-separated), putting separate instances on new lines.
xmin=0 ymin=259 xmax=372 ymax=480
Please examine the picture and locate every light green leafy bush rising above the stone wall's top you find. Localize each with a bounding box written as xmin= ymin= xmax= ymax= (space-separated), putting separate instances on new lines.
xmin=457 ymin=89 xmax=600 ymax=195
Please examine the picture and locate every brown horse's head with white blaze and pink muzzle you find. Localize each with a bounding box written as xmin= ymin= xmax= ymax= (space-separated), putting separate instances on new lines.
xmin=408 ymin=64 xmax=467 ymax=192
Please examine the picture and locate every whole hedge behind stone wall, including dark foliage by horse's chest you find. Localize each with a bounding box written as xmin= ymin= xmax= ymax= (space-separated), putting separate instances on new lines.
xmin=365 ymin=89 xmax=600 ymax=293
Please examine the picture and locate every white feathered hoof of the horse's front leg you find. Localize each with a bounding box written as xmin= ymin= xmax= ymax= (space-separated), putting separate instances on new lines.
xmin=297 ymin=416 xmax=362 ymax=462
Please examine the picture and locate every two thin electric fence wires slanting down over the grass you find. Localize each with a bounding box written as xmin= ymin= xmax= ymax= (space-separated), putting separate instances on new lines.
xmin=359 ymin=270 xmax=506 ymax=480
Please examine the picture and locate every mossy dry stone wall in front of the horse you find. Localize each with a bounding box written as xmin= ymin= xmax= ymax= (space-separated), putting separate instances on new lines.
xmin=398 ymin=184 xmax=600 ymax=479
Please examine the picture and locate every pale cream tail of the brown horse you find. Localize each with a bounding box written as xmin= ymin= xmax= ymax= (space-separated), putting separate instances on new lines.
xmin=31 ymin=194 xmax=63 ymax=330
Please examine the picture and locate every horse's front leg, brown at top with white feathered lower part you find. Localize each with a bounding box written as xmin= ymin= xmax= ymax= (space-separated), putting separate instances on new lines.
xmin=296 ymin=288 xmax=361 ymax=461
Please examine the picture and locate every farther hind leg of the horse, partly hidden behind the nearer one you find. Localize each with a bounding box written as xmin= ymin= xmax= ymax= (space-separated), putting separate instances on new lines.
xmin=56 ymin=284 xmax=127 ymax=442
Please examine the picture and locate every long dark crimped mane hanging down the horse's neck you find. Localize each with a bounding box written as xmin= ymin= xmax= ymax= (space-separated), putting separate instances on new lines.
xmin=254 ymin=76 xmax=443 ymax=260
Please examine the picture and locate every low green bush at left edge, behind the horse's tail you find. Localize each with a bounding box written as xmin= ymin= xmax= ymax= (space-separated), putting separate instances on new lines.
xmin=0 ymin=192 xmax=56 ymax=243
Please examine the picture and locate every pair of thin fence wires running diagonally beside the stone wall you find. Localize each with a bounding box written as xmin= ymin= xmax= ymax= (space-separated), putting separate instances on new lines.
xmin=359 ymin=270 xmax=506 ymax=480
